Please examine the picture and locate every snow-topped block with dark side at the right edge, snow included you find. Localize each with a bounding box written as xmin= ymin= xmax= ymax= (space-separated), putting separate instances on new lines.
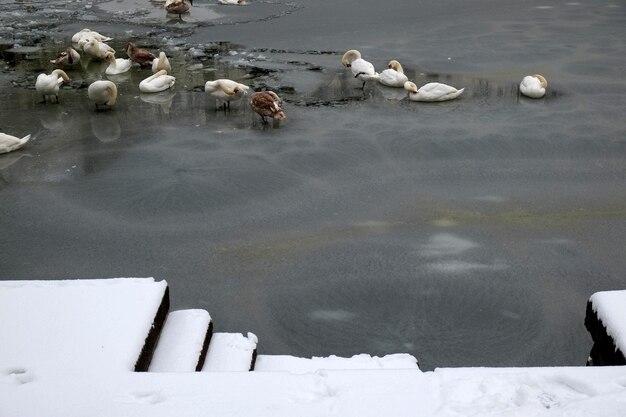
xmin=585 ymin=290 xmax=626 ymax=366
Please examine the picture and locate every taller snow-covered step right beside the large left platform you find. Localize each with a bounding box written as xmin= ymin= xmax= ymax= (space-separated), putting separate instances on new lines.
xmin=148 ymin=309 xmax=213 ymax=372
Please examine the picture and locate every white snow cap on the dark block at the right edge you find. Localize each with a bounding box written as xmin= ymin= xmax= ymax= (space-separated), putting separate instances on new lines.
xmin=589 ymin=291 xmax=626 ymax=354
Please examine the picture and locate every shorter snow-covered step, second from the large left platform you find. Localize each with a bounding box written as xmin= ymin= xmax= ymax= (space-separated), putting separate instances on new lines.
xmin=202 ymin=333 xmax=258 ymax=372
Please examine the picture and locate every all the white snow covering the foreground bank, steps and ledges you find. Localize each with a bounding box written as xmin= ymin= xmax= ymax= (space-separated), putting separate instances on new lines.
xmin=0 ymin=278 xmax=626 ymax=417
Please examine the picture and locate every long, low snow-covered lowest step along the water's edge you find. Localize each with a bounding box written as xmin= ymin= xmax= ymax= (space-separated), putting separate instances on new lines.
xmin=254 ymin=353 xmax=419 ymax=374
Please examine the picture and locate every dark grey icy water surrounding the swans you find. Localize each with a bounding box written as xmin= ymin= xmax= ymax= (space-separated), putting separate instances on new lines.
xmin=0 ymin=0 xmax=626 ymax=369
